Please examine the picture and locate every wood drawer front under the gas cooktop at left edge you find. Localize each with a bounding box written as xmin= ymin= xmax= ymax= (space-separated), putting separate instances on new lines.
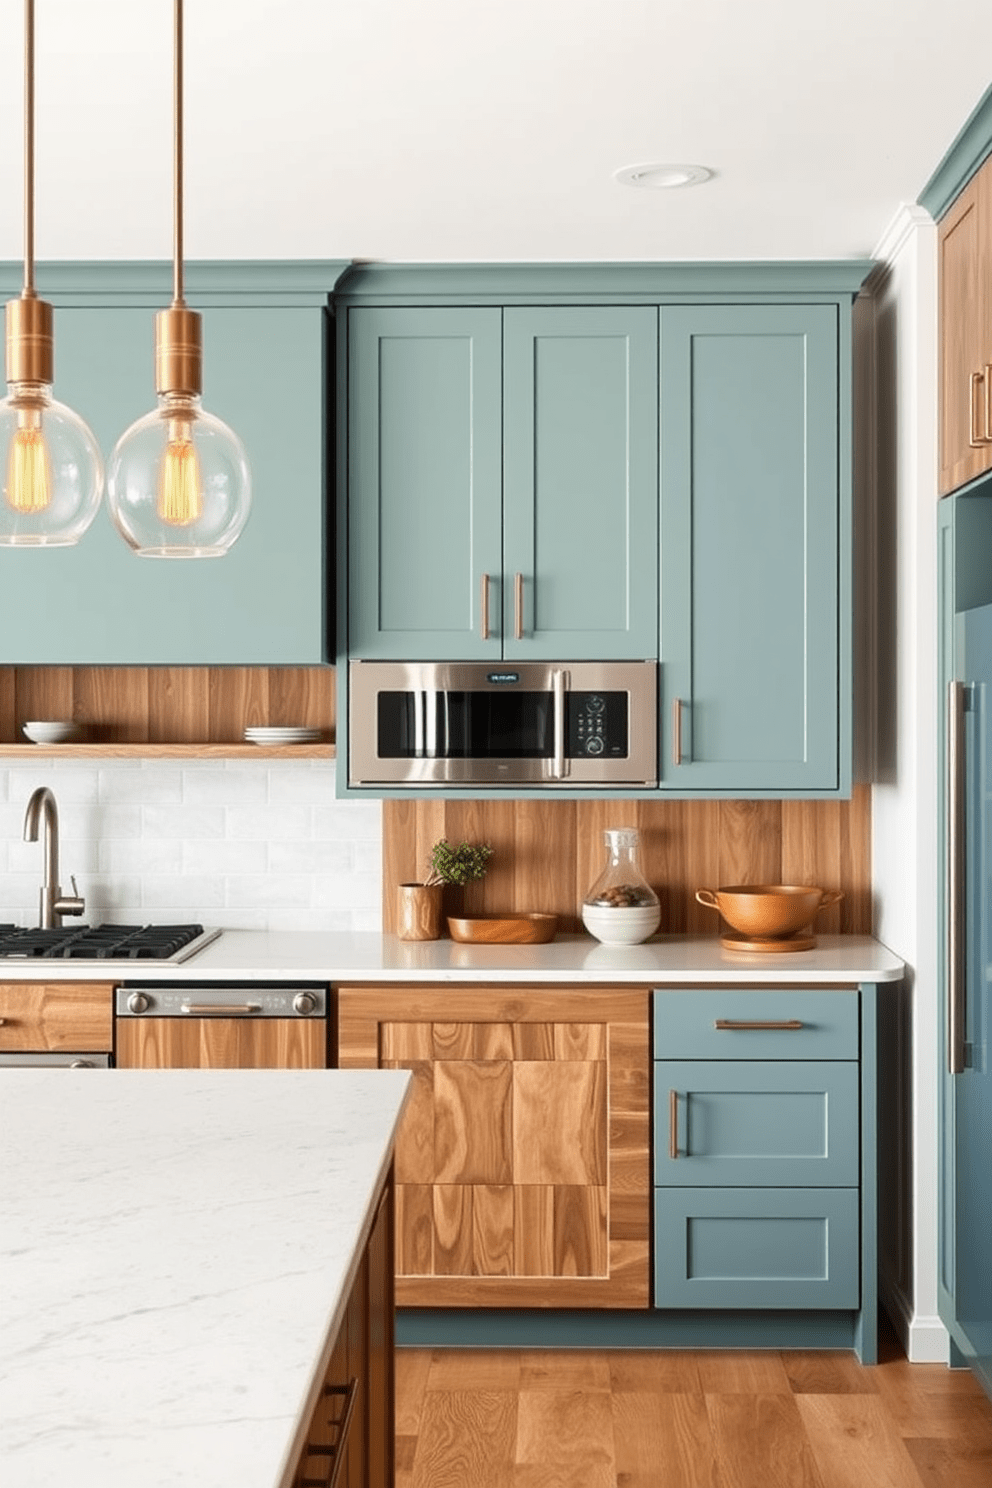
xmin=0 ymin=982 xmax=113 ymax=1054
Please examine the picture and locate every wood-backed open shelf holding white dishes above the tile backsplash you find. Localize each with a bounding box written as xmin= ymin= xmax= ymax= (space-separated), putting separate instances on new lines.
xmin=0 ymin=667 xmax=336 ymax=759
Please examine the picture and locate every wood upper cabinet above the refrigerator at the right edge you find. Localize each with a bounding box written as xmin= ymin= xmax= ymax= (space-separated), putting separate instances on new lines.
xmin=937 ymin=165 xmax=992 ymax=496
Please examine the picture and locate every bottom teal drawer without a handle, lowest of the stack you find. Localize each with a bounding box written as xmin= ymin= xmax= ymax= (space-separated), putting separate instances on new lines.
xmin=654 ymin=1189 xmax=861 ymax=1308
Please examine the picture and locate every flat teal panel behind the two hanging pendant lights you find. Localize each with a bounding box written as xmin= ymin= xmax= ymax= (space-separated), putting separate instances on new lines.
xmin=0 ymin=304 xmax=327 ymax=665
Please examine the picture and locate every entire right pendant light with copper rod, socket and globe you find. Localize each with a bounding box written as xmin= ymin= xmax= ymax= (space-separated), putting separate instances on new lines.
xmin=107 ymin=0 xmax=251 ymax=558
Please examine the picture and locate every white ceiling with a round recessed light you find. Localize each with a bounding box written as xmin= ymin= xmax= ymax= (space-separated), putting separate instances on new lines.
xmin=0 ymin=0 xmax=992 ymax=264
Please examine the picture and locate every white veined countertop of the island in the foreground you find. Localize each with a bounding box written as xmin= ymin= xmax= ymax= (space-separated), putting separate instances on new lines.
xmin=0 ymin=1070 xmax=409 ymax=1488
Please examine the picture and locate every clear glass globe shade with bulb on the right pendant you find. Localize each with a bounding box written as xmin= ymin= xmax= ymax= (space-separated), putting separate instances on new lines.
xmin=107 ymin=393 xmax=251 ymax=558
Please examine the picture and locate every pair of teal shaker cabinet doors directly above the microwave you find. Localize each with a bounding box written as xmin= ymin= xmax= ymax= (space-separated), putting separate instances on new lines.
xmin=348 ymin=305 xmax=657 ymax=661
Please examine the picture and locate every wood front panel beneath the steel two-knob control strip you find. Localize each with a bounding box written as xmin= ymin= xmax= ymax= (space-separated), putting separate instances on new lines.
xmin=116 ymin=1018 xmax=327 ymax=1070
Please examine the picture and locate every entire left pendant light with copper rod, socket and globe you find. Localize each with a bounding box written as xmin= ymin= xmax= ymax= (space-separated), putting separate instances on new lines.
xmin=0 ymin=0 xmax=103 ymax=548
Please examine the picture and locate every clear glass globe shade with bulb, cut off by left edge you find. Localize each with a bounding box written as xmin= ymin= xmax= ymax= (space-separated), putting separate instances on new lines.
xmin=0 ymin=382 xmax=103 ymax=548
